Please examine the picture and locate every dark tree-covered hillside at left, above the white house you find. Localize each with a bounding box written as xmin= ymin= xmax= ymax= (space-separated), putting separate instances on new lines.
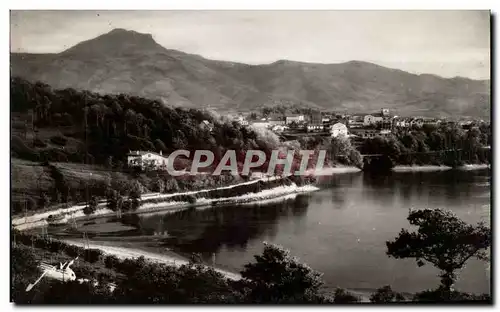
xmin=11 ymin=77 xmax=271 ymax=165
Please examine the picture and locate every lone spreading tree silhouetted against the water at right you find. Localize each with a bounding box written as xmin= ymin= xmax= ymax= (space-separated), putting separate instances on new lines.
xmin=386 ymin=209 xmax=491 ymax=295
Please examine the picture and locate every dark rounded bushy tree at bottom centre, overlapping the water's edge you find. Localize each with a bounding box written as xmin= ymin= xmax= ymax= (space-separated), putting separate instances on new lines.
xmin=241 ymin=243 xmax=325 ymax=303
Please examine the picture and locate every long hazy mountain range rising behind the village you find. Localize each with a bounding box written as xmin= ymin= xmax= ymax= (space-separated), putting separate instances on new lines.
xmin=11 ymin=29 xmax=490 ymax=118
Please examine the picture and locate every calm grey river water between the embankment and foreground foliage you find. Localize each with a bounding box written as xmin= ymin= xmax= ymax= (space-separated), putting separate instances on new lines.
xmin=49 ymin=170 xmax=491 ymax=293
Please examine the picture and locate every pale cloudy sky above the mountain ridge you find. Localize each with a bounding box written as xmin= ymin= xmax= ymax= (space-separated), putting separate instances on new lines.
xmin=10 ymin=11 xmax=490 ymax=79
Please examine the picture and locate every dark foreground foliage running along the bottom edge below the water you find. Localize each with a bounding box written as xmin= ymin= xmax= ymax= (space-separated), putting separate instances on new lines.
xmin=11 ymin=230 xmax=491 ymax=304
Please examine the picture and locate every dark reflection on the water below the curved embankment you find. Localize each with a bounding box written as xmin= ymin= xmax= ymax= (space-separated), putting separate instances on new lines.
xmin=135 ymin=195 xmax=310 ymax=257
